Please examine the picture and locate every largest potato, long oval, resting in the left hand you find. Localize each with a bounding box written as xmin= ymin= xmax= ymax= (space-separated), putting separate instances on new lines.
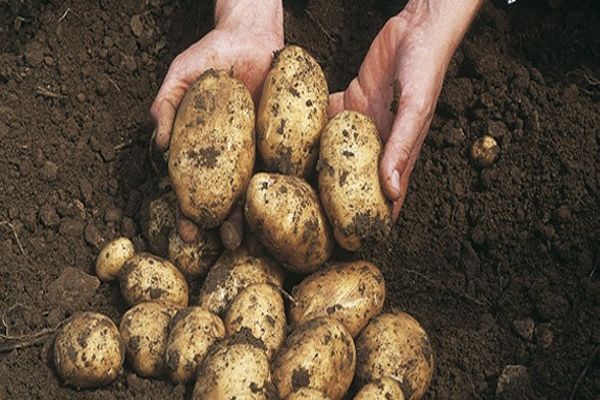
xmin=169 ymin=69 xmax=255 ymax=228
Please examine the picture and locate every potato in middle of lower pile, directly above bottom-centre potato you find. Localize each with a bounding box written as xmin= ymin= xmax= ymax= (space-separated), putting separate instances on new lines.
xmin=224 ymin=283 xmax=287 ymax=360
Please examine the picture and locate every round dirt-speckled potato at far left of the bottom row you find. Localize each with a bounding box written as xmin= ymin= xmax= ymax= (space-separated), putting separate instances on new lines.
xmin=54 ymin=312 xmax=125 ymax=388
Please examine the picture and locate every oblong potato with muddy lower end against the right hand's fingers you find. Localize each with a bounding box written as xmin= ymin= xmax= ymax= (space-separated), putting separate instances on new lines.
xmin=319 ymin=111 xmax=392 ymax=251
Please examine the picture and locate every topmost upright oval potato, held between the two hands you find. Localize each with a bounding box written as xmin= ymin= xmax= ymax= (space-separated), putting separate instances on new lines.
xmin=256 ymin=46 xmax=329 ymax=176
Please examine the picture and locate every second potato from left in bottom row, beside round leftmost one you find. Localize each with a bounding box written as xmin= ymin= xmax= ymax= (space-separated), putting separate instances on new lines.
xmin=119 ymin=303 xmax=177 ymax=378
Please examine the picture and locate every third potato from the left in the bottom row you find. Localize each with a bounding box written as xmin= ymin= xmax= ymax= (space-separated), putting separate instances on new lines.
xmin=165 ymin=307 xmax=225 ymax=383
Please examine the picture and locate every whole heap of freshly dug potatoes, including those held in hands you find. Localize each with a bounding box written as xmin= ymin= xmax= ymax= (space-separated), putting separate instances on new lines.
xmin=54 ymin=46 xmax=434 ymax=400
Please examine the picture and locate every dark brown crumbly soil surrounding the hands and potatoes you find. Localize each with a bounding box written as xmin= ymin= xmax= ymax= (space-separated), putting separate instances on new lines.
xmin=0 ymin=0 xmax=600 ymax=400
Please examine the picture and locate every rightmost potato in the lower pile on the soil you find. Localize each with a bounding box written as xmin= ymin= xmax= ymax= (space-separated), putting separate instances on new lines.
xmin=356 ymin=312 xmax=434 ymax=400
